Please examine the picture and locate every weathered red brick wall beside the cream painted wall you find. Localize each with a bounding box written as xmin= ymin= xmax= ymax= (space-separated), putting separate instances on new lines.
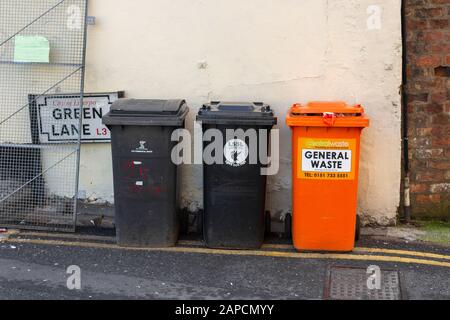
xmin=405 ymin=0 xmax=450 ymax=218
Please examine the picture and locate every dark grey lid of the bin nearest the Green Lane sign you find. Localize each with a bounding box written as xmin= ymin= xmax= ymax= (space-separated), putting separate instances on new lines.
xmin=103 ymin=99 xmax=189 ymax=126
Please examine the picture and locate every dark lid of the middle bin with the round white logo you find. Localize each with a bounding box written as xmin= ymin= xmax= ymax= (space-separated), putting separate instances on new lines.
xmin=197 ymin=101 xmax=277 ymax=126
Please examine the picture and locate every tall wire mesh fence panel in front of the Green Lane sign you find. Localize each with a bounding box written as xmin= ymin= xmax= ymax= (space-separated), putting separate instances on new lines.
xmin=0 ymin=0 xmax=87 ymax=231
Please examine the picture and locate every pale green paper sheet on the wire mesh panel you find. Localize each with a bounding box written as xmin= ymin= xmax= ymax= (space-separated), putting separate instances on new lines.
xmin=14 ymin=36 xmax=50 ymax=63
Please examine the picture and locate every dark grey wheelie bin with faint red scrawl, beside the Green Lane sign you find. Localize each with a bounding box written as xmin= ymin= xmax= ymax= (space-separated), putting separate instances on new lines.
xmin=103 ymin=99 xmax=189 ymax=247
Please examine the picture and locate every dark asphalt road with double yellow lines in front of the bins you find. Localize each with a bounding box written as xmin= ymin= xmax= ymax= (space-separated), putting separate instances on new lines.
xmin=0 ymin=229 xmax=450 ymax=300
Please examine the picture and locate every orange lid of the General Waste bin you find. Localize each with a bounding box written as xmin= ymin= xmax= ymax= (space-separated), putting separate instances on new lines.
xmin=286 ymin=101 xmax=369 ymax=128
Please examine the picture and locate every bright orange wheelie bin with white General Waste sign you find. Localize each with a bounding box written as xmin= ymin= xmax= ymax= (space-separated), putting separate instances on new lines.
xmin=286 ymin=102 xmax=369 ymax=252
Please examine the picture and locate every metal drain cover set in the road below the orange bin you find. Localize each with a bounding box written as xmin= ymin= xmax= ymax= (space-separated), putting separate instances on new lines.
xmin=324 ymin=266 xmax=402 ymax=300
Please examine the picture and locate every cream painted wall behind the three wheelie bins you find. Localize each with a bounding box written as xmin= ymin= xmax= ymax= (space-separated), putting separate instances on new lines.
xmin=80 ymin=0 xmax=402 ymax=224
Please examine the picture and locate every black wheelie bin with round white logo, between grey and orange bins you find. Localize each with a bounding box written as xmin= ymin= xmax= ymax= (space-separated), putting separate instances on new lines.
xmin=197 ymin=102 xmax=277 ymax=249
